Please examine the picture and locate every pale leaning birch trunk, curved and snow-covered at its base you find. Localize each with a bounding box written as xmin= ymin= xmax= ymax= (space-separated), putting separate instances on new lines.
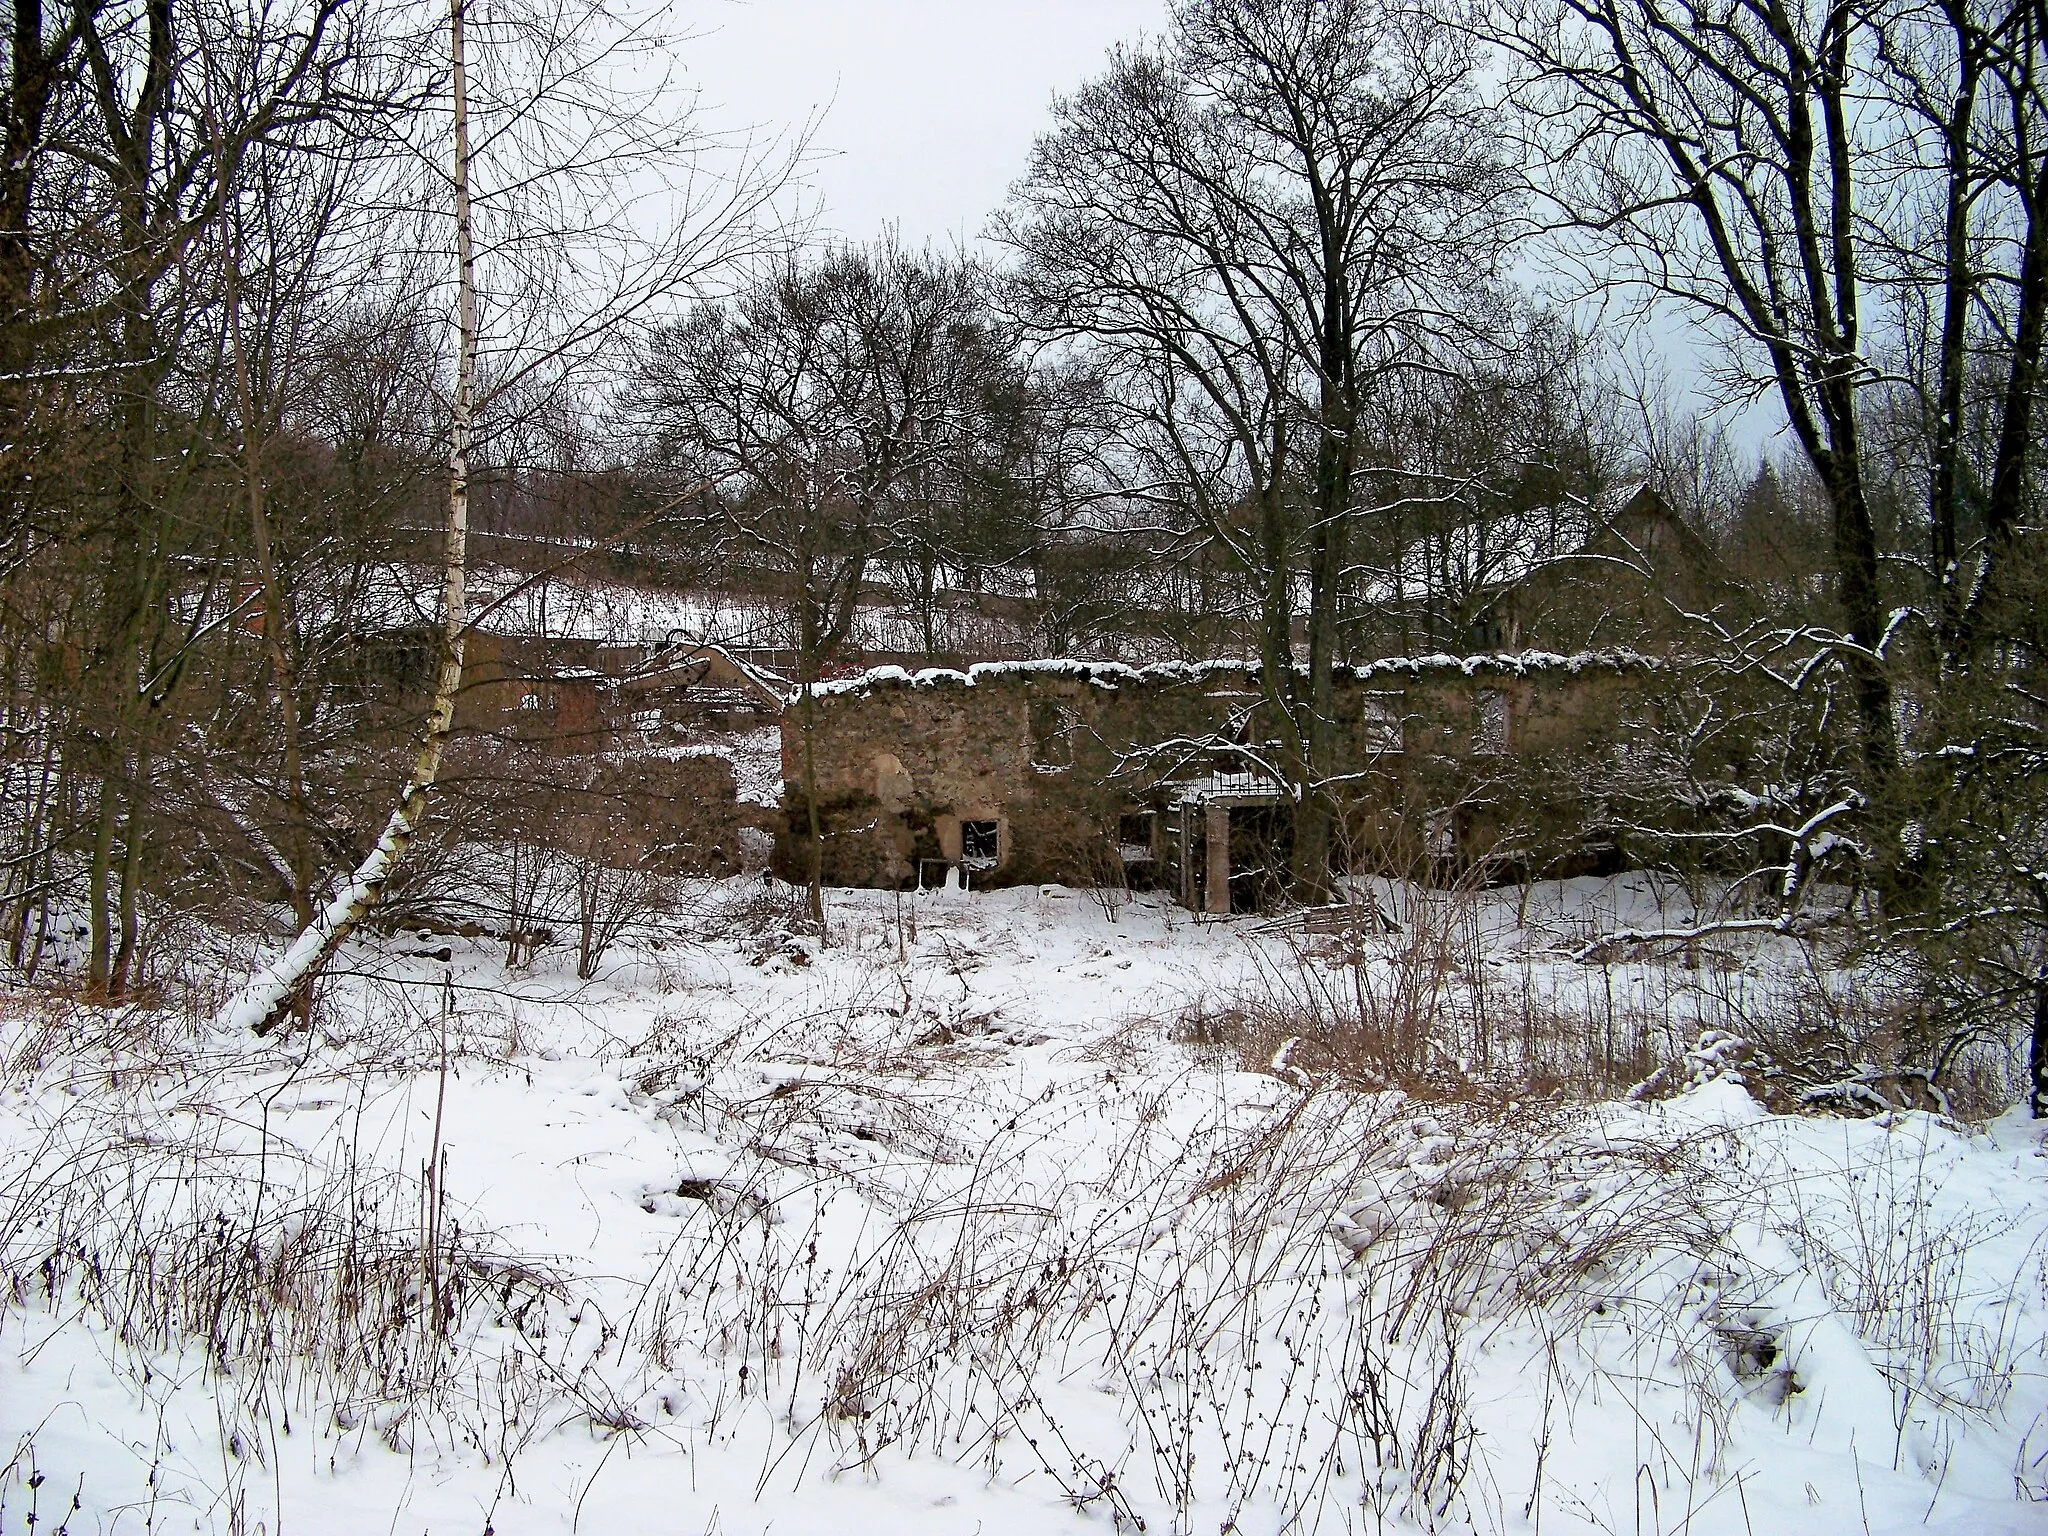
xmin=215 ymin=0 xmax=477 ymax=1034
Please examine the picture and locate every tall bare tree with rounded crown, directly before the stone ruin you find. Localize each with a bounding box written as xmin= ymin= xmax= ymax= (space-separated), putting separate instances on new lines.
xmin=1001 ymin=0 xmax=1501 ymax=897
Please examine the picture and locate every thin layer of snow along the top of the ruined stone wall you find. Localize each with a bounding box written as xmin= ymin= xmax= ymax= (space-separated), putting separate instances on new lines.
xmin=791 ymin=649 xmax=1665 ymax=702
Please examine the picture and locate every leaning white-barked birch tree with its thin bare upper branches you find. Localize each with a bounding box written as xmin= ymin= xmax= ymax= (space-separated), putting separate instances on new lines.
xmin=221 ymin=0 xmax=793 ymax=1030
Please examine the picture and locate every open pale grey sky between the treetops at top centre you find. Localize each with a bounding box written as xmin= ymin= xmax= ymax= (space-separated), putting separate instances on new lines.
xmin=678 ymin=0 xmax=1167 ymax=246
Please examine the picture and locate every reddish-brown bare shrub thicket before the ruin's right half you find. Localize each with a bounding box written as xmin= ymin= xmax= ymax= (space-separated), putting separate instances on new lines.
xmin=1196 ymin=847 xmax=2019 ymax=1118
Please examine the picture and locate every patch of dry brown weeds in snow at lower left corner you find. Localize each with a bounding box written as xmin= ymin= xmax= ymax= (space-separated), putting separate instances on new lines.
xmin=0 ymin=1081 xmax=577 ymax=1454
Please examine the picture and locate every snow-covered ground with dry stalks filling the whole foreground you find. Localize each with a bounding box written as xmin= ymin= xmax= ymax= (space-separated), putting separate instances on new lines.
xmin=0 ymin=879 xmax=2048 ymax=1536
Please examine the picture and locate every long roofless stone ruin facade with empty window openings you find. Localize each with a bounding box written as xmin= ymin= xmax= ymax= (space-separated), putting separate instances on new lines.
xmin=776 ymin=651 xmax=1744 ymax=913
